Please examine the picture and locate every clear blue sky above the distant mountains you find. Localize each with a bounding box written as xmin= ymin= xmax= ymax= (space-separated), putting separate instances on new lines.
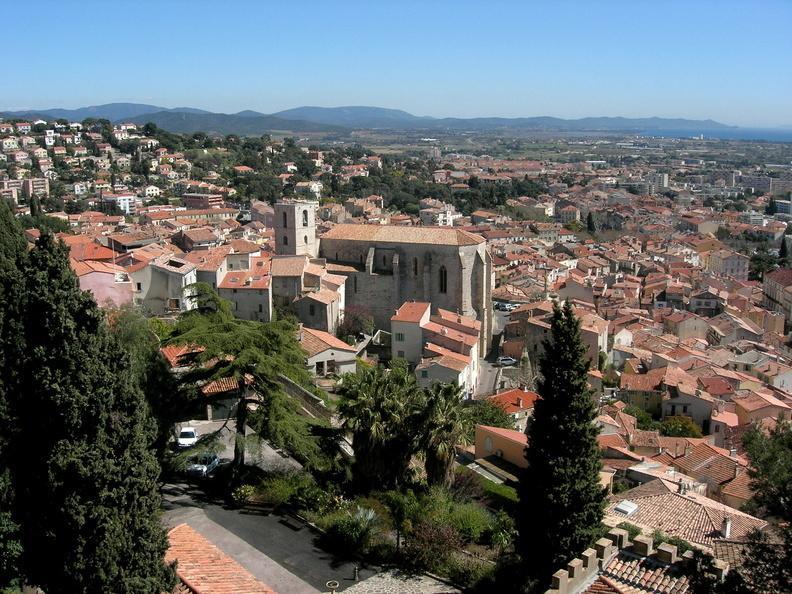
xmin=6 ymin=0 xmax=792 ymax=126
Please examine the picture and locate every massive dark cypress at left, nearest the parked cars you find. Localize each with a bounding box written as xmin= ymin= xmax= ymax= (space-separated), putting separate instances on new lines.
xmin=10 ymin=233 xmax=173 ymax=594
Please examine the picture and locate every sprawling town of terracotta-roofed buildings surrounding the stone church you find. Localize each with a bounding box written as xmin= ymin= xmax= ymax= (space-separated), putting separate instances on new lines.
xmin=0 ymin=113 xmax=792 ymax=594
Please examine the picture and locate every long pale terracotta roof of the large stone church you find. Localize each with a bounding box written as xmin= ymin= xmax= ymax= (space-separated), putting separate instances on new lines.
xmin=322 ymin=224 xmax=484 ymax=246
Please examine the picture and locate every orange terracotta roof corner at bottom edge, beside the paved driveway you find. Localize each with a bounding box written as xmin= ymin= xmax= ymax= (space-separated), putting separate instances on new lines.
xmin=165 ymin=524 xmax=276 ymax=594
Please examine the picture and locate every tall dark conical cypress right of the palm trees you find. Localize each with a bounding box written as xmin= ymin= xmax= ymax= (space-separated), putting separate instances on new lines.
xmin=519 ymin=302 xmax=605 ymax=591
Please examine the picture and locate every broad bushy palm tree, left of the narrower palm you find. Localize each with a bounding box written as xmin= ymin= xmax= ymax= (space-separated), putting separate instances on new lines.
xmin=338 ymin=365 xmax=425 ymax=491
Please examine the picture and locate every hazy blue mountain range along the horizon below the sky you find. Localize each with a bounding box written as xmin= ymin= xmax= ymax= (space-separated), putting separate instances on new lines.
xmin=0 ymin=103 xmax=736 ymax=135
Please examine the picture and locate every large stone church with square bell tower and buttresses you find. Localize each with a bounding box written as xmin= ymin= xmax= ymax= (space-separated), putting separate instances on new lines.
xmin=274 ymin=200 xmax=493 ymax=354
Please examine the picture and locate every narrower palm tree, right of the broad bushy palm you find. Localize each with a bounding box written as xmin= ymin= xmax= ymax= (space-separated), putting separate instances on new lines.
xmin=425 ymin=384 xmax=470 ymax=488
